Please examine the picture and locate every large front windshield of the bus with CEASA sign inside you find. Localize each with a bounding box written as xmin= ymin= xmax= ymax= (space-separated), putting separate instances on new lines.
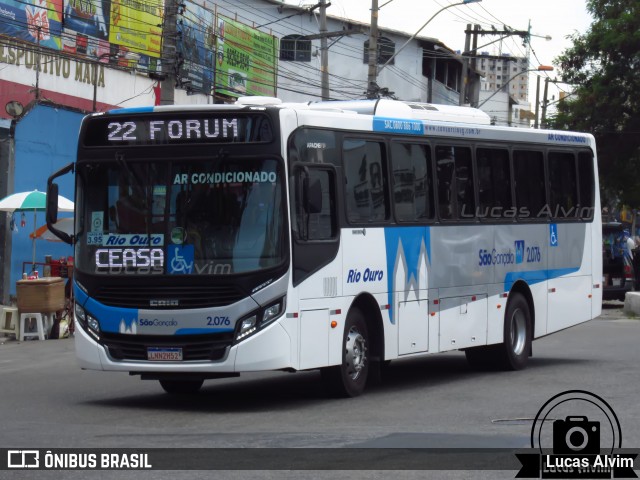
xmin=76 ymin=157 xmax=286 ymax=275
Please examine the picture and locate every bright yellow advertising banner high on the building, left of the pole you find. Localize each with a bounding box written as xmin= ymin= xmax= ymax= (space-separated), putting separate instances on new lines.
xmin=108 ymin=0 xmax=164 ymax=58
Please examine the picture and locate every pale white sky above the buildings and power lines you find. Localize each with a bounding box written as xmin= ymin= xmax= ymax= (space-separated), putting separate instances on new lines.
xmin=287 ymin=0 xmax=592 ymax=108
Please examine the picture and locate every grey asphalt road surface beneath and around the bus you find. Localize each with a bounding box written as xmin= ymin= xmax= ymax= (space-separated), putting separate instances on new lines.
xmin=0 ymin=303 xmax=640 ymax=479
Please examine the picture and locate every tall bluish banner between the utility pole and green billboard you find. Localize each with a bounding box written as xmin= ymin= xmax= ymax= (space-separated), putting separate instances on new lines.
xmin=177 ymin=2 xmax=215 ymax=95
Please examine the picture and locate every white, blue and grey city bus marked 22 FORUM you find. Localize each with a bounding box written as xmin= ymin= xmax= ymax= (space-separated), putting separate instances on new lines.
xmin=47 ymin=97 xmax=602 ymax=396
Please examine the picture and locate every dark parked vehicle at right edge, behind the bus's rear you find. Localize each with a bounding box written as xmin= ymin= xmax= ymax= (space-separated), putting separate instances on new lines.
xmin=602 ymin=222 xmax=640 ymax=301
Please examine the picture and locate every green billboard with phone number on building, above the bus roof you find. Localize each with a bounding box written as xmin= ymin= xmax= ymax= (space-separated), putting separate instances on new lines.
xmin=215 ymin=15 xmax=278 ymax=97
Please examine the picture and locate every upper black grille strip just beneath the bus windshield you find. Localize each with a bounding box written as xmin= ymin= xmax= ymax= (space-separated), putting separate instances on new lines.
xmin=94 ymin=285 xmax=246 ymax=309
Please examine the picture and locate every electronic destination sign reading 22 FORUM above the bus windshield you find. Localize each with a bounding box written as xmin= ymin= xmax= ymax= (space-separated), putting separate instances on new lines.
xmin=85 ymin=113 xmax=273 ymax=147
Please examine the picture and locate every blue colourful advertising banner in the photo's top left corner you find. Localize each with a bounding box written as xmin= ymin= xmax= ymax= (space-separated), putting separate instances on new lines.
xmin=0 ymin=0 xmax=62 ymax=50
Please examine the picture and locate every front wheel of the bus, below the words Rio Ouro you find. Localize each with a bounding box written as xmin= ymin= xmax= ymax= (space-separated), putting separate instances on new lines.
xmin=321 ymin=308 xmax=370 ymax=397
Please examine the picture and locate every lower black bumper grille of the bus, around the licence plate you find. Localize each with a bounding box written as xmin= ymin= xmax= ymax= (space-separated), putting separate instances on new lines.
xmin=101 ymin=332 xmax=233 ymax=361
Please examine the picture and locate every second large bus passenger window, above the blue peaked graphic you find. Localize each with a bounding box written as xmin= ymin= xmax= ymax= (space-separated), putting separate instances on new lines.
xmin=391 ymin=143 xmax=434 ymax=222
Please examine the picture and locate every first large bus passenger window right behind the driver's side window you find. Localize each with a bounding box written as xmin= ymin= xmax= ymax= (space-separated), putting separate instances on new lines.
xmin=343 ymin=140 xmax=389 ymax=223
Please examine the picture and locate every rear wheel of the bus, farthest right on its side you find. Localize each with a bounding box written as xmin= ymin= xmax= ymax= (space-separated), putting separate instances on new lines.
xmin=497 ymin=293 xmax=532 ymax=370
